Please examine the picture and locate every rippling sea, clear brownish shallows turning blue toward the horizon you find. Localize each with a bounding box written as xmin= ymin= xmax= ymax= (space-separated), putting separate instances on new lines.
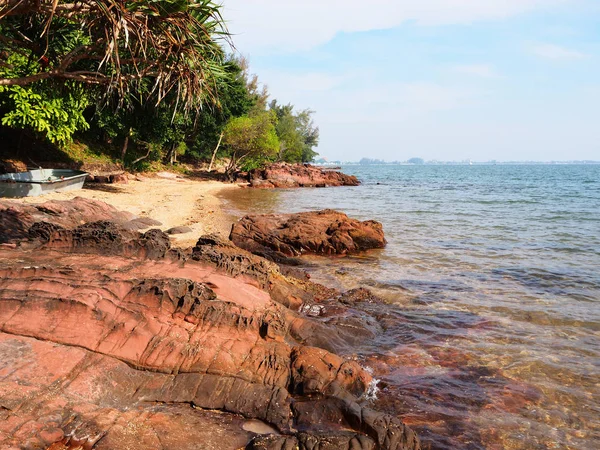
xmin=223 ymin=164 xmax=600 ymax=450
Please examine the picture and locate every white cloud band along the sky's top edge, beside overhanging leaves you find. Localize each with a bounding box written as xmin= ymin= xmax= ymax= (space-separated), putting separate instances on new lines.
xmin=222 ymin=0 xmax=574 ymax=52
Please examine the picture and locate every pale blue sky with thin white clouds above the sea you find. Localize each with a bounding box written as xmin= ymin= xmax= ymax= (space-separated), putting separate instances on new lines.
xmin=222 ymin=0 xmax=600 ymax=161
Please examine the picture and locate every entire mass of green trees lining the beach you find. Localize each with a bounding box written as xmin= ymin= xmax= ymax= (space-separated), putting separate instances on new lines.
xmin=0 ymin=0 xmax=319 ymax=173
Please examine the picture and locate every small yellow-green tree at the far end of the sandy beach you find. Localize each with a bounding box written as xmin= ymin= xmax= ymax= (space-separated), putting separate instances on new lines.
xmin=223 ymin=111 xmax=279 ymax=178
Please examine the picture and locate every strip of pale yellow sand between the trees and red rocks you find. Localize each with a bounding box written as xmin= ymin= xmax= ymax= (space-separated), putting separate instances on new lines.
xmin=20 ymin=173 xmax=239 ymax=247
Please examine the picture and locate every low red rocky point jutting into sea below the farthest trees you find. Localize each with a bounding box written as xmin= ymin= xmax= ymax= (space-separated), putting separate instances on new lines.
xmin=245 ymin=163 xmax=360 ymax=189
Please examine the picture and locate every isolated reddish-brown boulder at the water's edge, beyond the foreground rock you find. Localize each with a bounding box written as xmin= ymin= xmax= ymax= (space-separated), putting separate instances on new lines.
xmin=229 ymin=210 xmax=386 ymax=258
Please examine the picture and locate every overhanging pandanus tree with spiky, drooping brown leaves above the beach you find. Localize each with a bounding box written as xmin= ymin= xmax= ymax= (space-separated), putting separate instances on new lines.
xmin=0 ymin=0 xmax=227 ymax=108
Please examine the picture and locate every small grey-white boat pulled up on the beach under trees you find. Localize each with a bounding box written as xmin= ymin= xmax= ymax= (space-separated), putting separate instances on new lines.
xmin=0 ymin=168 xmax=88 ymax=197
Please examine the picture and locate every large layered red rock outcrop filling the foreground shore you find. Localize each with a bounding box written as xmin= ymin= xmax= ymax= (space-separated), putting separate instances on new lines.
xmin=0 ymin=207 xmax=419 ymax=450
